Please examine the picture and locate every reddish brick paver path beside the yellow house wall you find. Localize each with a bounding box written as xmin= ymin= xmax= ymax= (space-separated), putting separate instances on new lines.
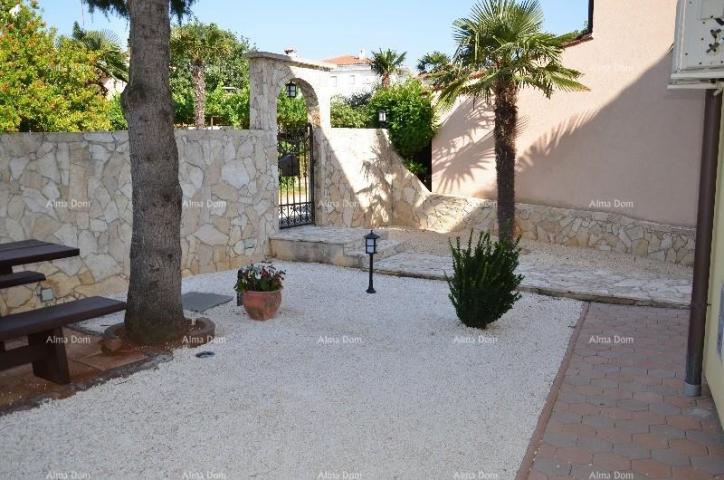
xmin=522 ymin=304 xmax=724 ymax=480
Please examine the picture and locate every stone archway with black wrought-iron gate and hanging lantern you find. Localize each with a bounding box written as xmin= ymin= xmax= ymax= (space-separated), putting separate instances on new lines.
xmin=249 ymin=52 xmax=334 ymax=228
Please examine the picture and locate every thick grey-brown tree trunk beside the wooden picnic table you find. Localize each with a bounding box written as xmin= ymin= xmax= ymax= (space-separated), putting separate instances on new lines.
xmin=123 ymin=0 xmax=186 ymax=344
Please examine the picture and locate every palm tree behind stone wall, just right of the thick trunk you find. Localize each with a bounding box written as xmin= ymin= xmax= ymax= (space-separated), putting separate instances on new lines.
xmin=171 ymin=22 xmax=235 ymax=128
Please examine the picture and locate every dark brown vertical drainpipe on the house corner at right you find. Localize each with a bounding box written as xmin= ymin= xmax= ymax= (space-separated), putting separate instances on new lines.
xmin=684 ymin=90 xmax=722 ymax=397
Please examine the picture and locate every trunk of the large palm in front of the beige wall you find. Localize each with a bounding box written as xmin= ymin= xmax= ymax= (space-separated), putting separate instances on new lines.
xmin=494 ymin=85 xmax=518 ymax=242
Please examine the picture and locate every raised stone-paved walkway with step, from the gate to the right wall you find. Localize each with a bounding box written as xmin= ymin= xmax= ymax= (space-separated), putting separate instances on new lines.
xmin=272 ymin=226 xmax=692 ymax=308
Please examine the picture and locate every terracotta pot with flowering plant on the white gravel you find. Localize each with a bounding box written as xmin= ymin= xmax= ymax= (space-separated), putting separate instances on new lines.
xmin=234 ymin=262 xmax=286 ymax=320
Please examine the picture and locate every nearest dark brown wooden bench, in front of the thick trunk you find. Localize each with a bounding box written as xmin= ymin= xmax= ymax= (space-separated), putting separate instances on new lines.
xmin=0 ymin=297 xmax=126 ymax=385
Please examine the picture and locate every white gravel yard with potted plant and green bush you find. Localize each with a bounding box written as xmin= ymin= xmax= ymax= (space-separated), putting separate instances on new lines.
xmin=0 ymin=263 xmax=581 ymax=480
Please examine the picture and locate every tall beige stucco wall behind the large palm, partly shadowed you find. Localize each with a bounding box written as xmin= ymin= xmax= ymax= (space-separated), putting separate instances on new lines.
xmin=433 ymin=0 xmax=704 ymax=226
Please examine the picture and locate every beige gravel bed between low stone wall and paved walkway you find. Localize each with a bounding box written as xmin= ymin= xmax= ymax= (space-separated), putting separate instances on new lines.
xmin=382 ymin=227 xmax=693 ymax=279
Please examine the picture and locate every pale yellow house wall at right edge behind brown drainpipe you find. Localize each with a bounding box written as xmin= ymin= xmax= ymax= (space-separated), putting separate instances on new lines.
xmin=704 ymin=100 xmax=724 ymax=426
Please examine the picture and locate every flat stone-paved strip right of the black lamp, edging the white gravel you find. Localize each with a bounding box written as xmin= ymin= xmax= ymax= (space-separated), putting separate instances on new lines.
xmin=375 ymin=252 xmax=691 ymax=308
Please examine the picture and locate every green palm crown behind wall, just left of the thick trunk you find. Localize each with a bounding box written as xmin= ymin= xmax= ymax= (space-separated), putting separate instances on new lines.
xmin=70 ymin=22 xmax=128 ymax=92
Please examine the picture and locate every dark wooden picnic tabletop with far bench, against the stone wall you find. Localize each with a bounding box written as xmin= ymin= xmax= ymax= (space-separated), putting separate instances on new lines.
xmin=0 ymin=240 xmax=80 ymax=288
